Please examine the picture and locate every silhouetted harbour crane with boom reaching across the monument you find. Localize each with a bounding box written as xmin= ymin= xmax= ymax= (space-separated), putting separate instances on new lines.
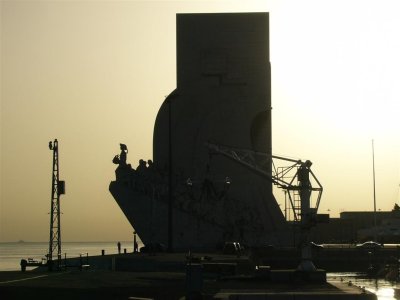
xmin=206 ymin=143 xmax=323 ymax=271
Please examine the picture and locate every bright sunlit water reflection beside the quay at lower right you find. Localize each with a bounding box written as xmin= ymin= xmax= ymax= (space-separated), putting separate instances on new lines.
xmin=327 ymin=273 xmax=400 ymax=300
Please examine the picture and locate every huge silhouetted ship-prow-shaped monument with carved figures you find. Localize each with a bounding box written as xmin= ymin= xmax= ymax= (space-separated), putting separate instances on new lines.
xmin=109 ymin=13 xmax=292 ymax=250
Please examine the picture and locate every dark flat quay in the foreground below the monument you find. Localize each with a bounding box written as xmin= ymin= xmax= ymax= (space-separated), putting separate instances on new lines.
xmin=0 ymin=253 xmax=376 ymax=300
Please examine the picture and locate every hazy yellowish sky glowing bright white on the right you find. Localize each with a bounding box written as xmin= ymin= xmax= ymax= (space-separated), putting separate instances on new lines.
xmin=0 ymin=0 xmax=400 ymax=241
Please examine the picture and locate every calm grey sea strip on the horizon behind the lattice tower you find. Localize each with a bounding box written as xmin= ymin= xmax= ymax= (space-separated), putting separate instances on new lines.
xmin=0 ymin=241 xmax=142 ymax=271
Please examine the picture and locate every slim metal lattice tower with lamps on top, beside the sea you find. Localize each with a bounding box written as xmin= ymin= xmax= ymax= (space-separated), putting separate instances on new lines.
xmin=48 ymin=139 xmax=65 ymax=268
